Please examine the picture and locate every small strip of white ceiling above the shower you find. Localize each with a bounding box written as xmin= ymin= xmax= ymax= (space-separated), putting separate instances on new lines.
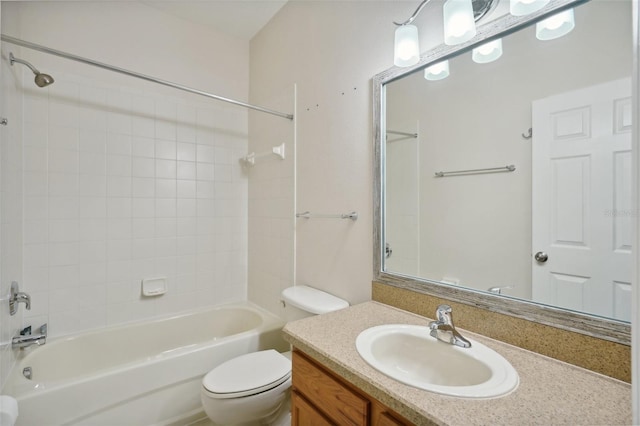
xmin=141 ymin=0 xmax=287 ymax=40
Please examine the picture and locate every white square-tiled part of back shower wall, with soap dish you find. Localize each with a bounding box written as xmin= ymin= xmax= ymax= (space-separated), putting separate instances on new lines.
xmin=23 ymin=70 xmax=248 ymax=335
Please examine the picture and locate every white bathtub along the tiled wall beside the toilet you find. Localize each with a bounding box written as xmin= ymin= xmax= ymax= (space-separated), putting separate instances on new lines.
xmin=6 ymin=302 xmax=289 ymax=426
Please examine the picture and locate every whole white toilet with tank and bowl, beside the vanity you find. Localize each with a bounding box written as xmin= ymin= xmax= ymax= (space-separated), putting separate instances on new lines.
xmin=200 ymin=285 xmax=349 ymax=425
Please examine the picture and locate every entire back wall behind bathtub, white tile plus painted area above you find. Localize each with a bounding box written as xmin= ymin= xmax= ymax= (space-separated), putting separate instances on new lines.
xmin=2 ymin=2 xmax=249 ymax=336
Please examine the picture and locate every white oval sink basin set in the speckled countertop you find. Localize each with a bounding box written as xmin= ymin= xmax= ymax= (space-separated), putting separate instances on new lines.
xmin=356 ymin=324 xmax=519 ymax=398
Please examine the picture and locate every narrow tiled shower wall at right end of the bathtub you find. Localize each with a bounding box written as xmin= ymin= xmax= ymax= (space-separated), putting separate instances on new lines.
xmin=246 ymin=85 xmax=296 ymax=313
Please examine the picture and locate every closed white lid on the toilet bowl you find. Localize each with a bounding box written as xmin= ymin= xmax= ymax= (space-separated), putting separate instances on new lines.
xmin=202 ymin=349 xmax=291 ymax=398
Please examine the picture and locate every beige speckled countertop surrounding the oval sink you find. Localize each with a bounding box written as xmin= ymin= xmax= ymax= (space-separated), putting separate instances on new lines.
xmin=284 ymin=302 xmax=632 ymax=425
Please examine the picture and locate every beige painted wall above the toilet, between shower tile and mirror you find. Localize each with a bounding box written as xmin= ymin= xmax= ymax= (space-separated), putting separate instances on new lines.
xmin=249 ymin=1 xmax=412 ymax=310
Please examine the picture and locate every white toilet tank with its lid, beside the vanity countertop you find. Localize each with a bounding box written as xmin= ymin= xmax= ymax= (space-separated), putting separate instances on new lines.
xmin=282 ymin=285 xmax=349 ymax=321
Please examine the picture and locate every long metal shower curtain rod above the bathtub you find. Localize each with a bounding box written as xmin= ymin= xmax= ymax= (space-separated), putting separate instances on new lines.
xmin=1 ymin=34 xmax=293 ymax=120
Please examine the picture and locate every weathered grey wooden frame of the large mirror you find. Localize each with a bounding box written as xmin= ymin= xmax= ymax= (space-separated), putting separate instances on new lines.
xmin=373 ymin=0 xmax=637 ymax=346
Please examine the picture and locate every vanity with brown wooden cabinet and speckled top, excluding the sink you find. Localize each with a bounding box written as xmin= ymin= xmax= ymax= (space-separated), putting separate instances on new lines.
xmin=284 ymin=302 xmax=632 ymax=425
